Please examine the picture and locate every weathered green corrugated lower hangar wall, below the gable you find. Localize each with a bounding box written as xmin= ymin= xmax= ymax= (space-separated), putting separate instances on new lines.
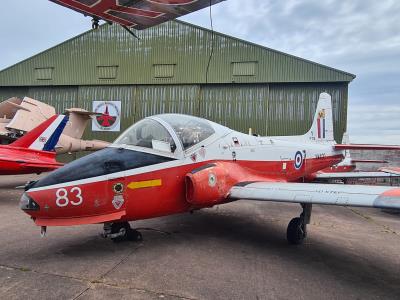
xmin=0 ymin=83 xmax=347 ymax=141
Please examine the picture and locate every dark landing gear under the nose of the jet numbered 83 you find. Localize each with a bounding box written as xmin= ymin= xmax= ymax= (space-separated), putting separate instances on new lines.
xmin=103 ymin=222 xmax=143 ymax=243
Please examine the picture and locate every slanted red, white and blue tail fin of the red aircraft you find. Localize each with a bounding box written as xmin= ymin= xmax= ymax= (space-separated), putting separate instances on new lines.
xmin=10 ymin=115 xmax=68 ymax=151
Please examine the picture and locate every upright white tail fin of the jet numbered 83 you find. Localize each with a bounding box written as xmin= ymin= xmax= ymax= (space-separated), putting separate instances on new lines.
xmin=304 ymin=93 xmax=334 ymax=142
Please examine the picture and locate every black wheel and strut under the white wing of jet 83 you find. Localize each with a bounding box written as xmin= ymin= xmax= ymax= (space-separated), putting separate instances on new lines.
xmin=286 ymin=203 xmax=312 ymax=245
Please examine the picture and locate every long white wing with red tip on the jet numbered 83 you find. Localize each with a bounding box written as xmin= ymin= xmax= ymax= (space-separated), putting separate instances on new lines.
xmin=228 ymin=182 xmax=400 ymax=209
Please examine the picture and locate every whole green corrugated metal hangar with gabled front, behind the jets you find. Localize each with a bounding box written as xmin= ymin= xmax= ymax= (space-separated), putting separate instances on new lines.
xmin=0 ymin=21 xmax=355 ymax=141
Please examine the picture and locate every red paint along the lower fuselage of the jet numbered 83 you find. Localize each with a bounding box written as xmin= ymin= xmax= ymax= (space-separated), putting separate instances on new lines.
xmin=29 ymin=155 xmax=342 ymax=225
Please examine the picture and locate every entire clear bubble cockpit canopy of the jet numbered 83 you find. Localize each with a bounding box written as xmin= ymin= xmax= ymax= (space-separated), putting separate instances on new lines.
xmin=115 ymin=114 xmax=215 ymax=153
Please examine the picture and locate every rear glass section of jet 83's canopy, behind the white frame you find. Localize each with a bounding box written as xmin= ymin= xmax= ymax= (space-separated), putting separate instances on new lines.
xmin=157 ymin=114 xmax=215 ymax=150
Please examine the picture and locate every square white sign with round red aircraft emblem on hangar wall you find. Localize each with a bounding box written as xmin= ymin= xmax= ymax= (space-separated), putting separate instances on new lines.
xmin=92 ymin=101 xmax=121 ymax=131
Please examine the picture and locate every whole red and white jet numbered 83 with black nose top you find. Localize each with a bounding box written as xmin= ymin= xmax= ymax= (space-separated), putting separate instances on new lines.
xmin=20 ymin=93 xmax=400 ymax=244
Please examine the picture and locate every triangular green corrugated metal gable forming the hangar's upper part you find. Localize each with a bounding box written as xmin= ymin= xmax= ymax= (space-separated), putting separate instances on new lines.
xmin=0 ymin=21 xmax=355 ymax=86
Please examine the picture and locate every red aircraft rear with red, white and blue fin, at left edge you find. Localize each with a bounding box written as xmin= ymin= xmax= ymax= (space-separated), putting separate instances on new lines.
xmin=0 ymin=115 xmax=68 ymax=175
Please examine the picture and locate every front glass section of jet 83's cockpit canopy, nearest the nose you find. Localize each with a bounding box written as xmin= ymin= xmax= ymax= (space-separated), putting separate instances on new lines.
xmin=114 ymin=119 xmax=176 ymax=153
